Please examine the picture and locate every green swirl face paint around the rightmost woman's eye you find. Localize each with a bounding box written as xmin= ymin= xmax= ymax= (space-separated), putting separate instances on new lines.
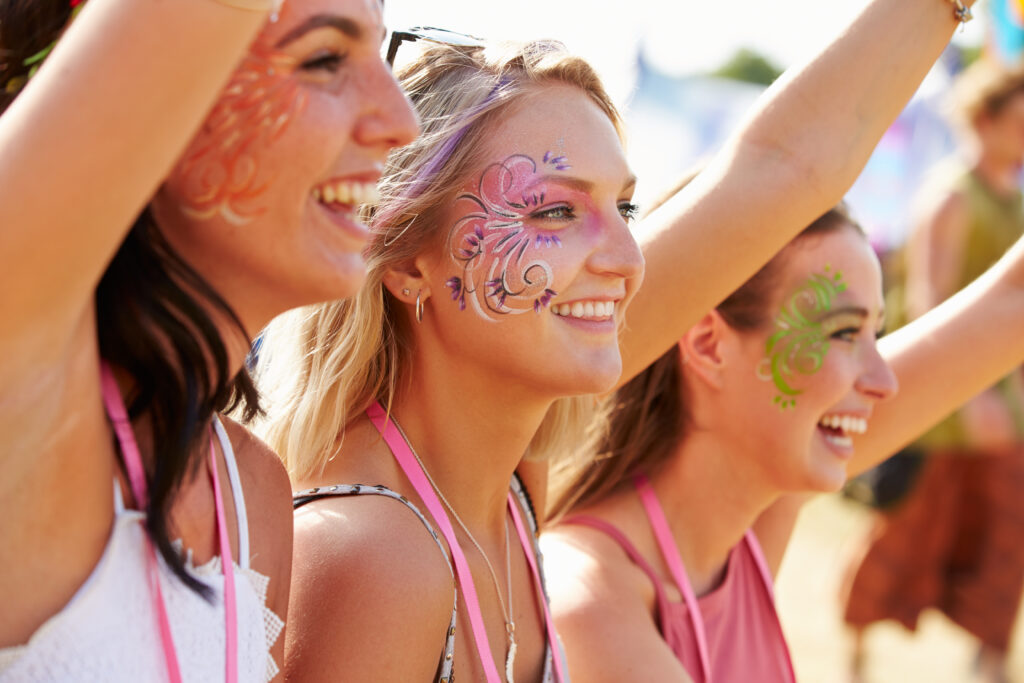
xmin=758 ymin=266 xmax=846 ymax=411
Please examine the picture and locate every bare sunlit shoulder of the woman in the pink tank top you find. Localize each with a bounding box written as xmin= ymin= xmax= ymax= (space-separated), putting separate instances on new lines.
xmin=541 ymin=525 xmax=690 ymax=683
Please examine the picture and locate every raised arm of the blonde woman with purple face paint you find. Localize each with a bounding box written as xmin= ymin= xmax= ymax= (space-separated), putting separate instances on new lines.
xmin=621 ymin=0 xmax=970 ymax=383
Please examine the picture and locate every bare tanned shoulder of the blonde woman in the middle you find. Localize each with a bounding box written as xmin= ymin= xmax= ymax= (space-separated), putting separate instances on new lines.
xmin=285 ymin=495 xmax=455 ymax=681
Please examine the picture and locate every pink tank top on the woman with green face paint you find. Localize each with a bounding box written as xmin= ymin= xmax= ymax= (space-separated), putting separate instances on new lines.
xmin=562 ymin=476 xmax=796 ymax=683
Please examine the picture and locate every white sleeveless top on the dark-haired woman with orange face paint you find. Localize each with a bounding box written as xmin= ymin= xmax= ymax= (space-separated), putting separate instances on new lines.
xmin=0 ymin=418 xmax=284 ymax=683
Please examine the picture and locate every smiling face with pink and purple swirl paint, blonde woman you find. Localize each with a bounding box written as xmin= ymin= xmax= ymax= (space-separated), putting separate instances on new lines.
xmin=418 ymin=85 xmax=643 ymax=397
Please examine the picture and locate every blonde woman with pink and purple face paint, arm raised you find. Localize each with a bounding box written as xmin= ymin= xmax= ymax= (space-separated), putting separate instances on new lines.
xmin=261 ymin=0 xmax=974 ymax=681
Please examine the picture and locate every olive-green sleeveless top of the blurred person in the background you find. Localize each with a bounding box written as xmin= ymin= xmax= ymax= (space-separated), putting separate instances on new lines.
xmin=918 ymin=165 xmax=1024 ymax=450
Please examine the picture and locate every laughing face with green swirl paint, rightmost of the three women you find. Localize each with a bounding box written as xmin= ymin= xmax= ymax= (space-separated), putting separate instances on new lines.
xmin=727 ymin=226 xmax=896 ymax=492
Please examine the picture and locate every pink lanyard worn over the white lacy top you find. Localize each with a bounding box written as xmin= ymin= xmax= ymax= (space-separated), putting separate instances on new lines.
xmin=99 ymin=362 xmax=239 ymax=683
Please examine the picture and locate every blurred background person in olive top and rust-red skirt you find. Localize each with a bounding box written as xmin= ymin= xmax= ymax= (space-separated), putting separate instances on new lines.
xmin=845 ymin=61 xmax=1024 ymax=681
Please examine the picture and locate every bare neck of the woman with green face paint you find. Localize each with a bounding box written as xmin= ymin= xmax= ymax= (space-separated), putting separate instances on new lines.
xmin=652 ymin=431 xmax=777 ymax=596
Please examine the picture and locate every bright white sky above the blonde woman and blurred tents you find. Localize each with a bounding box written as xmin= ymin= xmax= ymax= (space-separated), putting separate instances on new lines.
xmin=385 ymin=0 xmax=982 ymax=107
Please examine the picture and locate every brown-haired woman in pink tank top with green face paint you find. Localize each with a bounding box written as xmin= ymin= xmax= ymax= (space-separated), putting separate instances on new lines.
xmin=543 ymin=194 xmax=1024 ymax=683
